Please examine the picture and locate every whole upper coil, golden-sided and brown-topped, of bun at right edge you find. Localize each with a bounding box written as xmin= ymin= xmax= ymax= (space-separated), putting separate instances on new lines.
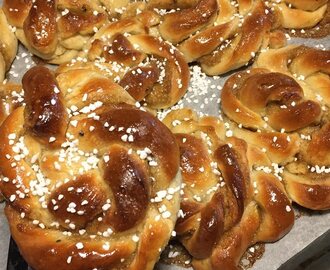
xmin=222 ymin=69 xmax=321 ymax=131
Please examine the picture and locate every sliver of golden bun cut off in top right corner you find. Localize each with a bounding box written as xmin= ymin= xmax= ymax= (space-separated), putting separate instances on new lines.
xmin=272 ymin=0 xmax=328 ymax=29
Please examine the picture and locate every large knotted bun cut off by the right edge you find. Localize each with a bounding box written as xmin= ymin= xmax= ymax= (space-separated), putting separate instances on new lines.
xmin=221 ymin=45 xmax=330 ymax=210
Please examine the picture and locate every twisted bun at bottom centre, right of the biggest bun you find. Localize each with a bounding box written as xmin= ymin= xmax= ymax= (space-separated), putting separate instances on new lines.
xmin=164 ymin=109 xmax=294 ymax=269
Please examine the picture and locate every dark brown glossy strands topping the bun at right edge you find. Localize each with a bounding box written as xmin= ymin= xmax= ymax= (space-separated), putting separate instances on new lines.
xmin=239 ymin=73 xmax=321 ymax=131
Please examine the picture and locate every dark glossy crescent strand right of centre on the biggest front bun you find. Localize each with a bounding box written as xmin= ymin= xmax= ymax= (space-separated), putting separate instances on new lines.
xmin=104 ymin=146 xmax=149 ymax=231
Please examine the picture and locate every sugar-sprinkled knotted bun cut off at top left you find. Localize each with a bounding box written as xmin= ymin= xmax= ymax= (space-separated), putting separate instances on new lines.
xmin=3 ymin=0 xmax=113 ymax=64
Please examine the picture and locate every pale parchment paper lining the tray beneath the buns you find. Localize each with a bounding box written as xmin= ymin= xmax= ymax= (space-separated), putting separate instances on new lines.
xmin=0 ymin=0 xmax=330 ymax=270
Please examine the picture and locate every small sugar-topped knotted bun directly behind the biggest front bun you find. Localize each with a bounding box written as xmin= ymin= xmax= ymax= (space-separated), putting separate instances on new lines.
xmin=58 ymin=18 xmax=190 ymax=108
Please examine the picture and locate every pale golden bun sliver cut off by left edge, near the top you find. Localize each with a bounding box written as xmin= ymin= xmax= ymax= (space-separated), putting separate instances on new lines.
xmin=0 ymin=9 xmax=17 ymax=82
